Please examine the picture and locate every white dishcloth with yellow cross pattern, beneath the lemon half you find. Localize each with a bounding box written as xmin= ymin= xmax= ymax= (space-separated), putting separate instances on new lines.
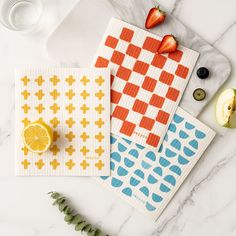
xmin=15 ymin=68 xmax=110 ymax=176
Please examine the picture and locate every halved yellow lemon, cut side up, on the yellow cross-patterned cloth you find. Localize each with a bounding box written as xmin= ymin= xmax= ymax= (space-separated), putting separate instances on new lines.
xmin=22 ymin=121 xmax=53 ymax=153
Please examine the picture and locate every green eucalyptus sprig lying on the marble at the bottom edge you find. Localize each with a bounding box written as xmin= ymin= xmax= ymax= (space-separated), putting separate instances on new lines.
xmin=48 ymin=192 xmax=108 ymax=236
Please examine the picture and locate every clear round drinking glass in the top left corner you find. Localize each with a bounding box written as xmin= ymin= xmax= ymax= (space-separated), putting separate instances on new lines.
xmin=0 ymin=0 xmax=42 ymax=32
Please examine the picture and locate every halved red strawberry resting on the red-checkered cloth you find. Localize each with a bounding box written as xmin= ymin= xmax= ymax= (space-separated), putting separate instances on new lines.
xmin=157 ymin=35 xmax=178 ymax=54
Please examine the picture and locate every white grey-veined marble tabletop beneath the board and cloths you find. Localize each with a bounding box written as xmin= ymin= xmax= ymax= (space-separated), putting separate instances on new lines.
xmin=0 ymin=0 xmax=236 ymax=236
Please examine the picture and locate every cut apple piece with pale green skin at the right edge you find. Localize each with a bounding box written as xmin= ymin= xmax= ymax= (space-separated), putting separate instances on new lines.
xmin=216 ymin=89 xmax=236 ymax=128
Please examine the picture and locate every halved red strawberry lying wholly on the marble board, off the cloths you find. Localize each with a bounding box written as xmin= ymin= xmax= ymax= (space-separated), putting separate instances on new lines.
xmin=145 ymin=6 xmax=166 ymax=29
